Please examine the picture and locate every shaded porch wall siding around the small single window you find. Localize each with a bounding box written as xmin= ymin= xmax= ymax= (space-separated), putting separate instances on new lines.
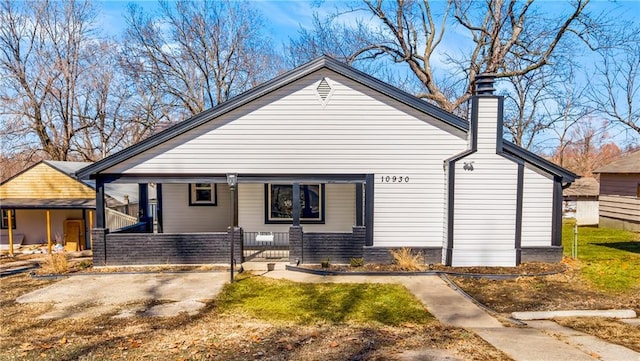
xmin=162 ymin=184 xmax=231 ymax=233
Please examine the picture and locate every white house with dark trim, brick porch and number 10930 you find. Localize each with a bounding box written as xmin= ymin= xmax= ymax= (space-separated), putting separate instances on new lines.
xmin=78 ymin=57 xmax=576 ymax=266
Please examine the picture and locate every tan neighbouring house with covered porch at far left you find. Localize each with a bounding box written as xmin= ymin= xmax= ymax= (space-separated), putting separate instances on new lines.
xmin=0 ymin=161 xmax=138 ymax=251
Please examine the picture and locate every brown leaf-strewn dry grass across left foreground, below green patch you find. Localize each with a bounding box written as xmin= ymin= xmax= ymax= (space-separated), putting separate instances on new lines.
xmin=0 ymin=275 xmax=509 ymax=361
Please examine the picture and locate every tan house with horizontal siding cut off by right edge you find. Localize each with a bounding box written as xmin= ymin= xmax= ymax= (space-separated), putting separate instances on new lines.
xmin=594 ymin=151 xmax=640 ymax=232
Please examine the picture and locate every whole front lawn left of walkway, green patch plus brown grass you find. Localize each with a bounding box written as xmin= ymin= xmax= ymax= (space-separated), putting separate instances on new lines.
xmin=0 ymin=274 xmax=509 ymax=361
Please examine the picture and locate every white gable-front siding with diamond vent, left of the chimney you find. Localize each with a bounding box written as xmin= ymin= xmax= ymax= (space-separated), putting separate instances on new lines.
xmin=105 ymin=70 xmax=466 ymax=247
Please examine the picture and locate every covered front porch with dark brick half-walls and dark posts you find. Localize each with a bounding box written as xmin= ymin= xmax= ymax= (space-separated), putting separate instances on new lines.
xmin=87 ymin=175 xmax=374 ymax=266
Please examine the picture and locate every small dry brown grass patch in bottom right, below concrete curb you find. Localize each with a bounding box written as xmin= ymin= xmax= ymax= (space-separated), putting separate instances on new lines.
xmin=555 ymin=317 xmax=640 ymax=352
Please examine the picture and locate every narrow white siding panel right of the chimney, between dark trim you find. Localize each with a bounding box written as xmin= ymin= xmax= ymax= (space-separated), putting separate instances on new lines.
xmin=521 ymin=167 xmax=556 ymax=247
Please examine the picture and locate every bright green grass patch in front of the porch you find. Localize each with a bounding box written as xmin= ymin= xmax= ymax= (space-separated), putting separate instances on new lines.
xmin=218 ymin=275 xmax=434 ymax=326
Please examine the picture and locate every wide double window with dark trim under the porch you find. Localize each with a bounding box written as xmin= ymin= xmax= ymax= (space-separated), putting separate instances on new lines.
xmin=264 ymin=184 xmax=325 ymax=223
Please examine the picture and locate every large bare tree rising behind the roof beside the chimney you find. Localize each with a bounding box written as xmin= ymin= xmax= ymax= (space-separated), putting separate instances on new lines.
xmin=294 ymin=0 xmax=595 ymax=111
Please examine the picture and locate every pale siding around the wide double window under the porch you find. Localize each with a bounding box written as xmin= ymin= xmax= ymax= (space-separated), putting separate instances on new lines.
xmin=238 ymin=183 xmax=356 ymax=232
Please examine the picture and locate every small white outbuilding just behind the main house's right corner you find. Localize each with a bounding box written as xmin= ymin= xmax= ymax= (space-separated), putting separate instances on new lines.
xmin=562 ymin=178 xmax=600 ymax=226
